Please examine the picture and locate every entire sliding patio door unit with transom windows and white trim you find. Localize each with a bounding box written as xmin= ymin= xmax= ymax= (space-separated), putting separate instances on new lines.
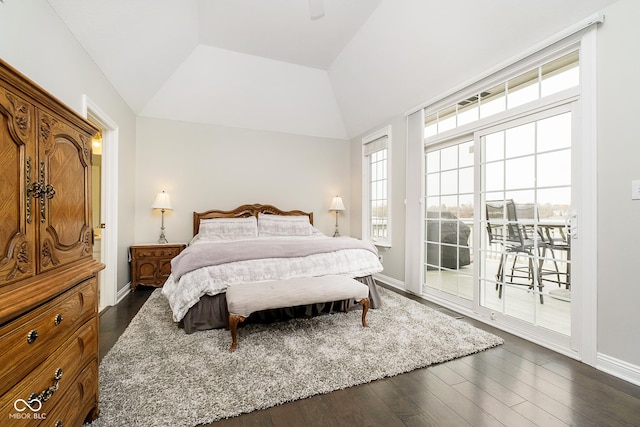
xmin=416 ymin=32 xmax=597 ymax=361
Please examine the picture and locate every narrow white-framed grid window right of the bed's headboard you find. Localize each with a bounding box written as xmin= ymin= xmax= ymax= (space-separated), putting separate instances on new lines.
xmin=362 ymin=126 xmax=391 ymax=247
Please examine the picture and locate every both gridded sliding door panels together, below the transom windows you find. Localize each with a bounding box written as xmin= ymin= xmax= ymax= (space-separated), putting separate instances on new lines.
xmin=422 ymin=103 xmax=575 ymax=347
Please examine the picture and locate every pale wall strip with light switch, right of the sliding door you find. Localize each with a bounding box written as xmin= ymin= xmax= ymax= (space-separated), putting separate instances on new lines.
xmin=597 ymin=0 xmax=640 ymax=372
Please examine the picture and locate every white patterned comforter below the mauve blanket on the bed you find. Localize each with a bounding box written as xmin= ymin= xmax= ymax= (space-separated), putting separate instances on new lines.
xmin=162 ymin=237 xmax=383 ymax=322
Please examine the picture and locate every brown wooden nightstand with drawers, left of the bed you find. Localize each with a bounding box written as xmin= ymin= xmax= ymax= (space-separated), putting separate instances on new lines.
xmin=129 ymin=243 xmax=187 ymax=292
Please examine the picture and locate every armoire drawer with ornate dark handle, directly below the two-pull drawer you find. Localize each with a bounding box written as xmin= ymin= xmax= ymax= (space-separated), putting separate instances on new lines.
xmin=0 ymin=318 xmax=98 ymax=425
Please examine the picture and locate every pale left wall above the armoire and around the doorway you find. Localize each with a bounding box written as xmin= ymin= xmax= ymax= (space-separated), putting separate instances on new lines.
xmin=0 ymin=0 xmax=135 ymax=294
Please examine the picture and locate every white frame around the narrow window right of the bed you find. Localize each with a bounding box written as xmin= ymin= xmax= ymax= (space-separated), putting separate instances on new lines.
xmin=362 ymin=125 xmax=393 ymax=248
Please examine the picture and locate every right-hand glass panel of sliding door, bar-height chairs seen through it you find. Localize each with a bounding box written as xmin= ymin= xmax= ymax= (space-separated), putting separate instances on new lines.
xmin=475 ymin=104 xmax=573 ymax=336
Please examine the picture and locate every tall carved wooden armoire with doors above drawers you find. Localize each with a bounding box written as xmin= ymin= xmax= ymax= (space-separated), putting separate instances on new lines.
xmin=0 ymin=60 xmax=103 ymax=427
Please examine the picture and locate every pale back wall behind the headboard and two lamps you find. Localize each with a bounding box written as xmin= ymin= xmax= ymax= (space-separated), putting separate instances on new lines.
xmin=135 ymin=117 xmax=350 ymax=243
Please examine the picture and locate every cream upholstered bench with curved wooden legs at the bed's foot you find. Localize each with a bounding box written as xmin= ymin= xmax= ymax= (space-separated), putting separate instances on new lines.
xmin=227 ymin=276 xmax=369 ymax=351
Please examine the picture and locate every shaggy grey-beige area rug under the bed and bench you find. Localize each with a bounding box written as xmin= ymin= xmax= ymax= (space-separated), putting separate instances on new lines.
xmin=92 ymin=289 xmax=503 ymax=427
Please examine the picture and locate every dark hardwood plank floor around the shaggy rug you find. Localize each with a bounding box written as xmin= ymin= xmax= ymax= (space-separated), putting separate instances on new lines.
xmin=100 ymin=287 xmax=640 ymax=427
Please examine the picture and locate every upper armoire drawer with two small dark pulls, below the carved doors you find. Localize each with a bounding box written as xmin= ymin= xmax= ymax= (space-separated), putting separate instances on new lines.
xmin=0 ymin=278 xmax=98 ymax=395
